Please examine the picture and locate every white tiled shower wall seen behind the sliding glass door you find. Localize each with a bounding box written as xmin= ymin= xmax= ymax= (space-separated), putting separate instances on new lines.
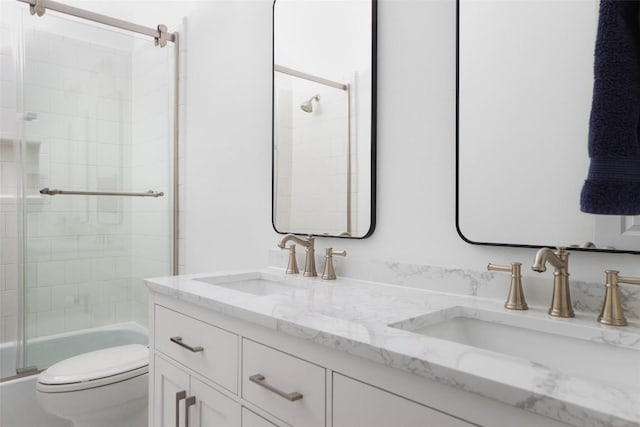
xmin=0 ymin=5 xmax=172 ymax=342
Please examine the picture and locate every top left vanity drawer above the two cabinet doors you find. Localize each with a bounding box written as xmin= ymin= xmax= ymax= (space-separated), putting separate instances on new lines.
xmin=154 ymin=305 xmax=238 ymax=393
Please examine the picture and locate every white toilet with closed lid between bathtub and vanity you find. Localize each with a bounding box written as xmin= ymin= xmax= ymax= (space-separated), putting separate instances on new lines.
xmin=36 ymin=344 xmax=149 ymax=427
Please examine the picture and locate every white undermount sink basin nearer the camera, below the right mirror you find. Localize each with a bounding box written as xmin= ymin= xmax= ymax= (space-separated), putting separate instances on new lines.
xmin=389 ymin=307 xmax=640 ymax=391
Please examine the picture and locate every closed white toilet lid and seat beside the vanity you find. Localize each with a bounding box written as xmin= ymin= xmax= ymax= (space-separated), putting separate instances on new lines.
xmin=36 ymin=344 xmax=149 ymax=393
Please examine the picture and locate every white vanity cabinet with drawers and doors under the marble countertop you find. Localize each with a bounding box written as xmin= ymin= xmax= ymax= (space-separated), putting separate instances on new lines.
xmin=149 ymin=293 xmax=564 ymax=427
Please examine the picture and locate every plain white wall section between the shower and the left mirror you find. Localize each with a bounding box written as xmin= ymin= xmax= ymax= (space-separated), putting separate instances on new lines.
xmin=183 ymin=0 xmax=277 ymax=272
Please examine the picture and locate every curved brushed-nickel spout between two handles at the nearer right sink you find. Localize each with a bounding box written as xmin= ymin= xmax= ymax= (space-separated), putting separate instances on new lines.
xmin=531 ymin=247 xmax=575 ymax=317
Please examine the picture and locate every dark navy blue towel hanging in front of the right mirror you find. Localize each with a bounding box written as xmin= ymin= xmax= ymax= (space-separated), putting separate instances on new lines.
xmin=580 ymin=0 xmax=640 ymax=215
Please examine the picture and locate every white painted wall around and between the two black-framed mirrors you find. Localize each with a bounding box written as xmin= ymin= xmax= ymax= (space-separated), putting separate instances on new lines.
xmin=185 ymin=0 xmax=640 ymax=286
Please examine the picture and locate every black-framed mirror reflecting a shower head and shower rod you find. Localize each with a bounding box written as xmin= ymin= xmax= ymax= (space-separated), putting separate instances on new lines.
xmin=272 ymin=0 xmax=377 ymax=238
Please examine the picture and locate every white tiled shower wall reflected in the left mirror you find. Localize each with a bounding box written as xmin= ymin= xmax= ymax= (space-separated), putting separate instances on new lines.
xmin=275 ymin=74 xmax=350 ymax=235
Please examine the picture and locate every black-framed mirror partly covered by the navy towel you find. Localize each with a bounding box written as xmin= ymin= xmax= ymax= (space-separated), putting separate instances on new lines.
xmin=456 ymin=0 xmax=640 ymax=253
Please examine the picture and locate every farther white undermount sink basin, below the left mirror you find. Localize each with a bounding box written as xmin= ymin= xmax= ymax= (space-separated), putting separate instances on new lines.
xmin=195 ymin=273 xmax=306 ymax=296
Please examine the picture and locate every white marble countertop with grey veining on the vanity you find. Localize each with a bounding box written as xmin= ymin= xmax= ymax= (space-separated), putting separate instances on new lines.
xmin=146 ymin=269 xmax=640 ymax=426
